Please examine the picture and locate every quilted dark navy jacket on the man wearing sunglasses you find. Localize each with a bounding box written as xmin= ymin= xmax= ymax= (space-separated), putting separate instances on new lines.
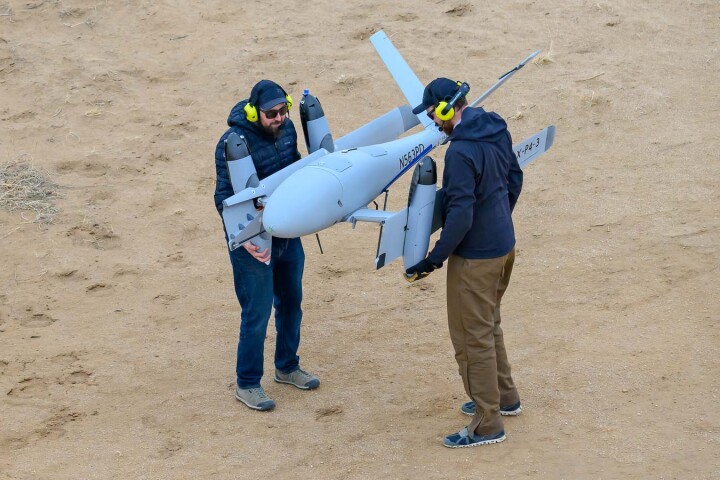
xmin=215 ymin=100 xmax=300 ymax=213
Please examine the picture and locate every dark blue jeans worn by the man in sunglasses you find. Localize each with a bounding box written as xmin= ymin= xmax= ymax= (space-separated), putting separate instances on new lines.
xmin=230 ymin=237 xmax=305 ymax=388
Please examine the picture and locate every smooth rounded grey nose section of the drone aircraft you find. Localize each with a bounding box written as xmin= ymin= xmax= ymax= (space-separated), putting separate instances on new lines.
xmin=263 ymin=166 xmax=342 ymax=238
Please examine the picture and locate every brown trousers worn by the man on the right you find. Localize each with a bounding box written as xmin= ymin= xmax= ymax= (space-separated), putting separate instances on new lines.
xmin=447 ymin=248 xmax=520 ymax=435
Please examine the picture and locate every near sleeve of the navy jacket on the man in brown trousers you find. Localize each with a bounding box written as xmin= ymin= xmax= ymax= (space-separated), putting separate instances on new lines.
xmin=428 ymin=150 xmax=480 ymax=265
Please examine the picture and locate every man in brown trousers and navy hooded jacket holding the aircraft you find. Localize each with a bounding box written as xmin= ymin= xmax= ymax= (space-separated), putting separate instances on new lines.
xmin=407 ymin=78 xmax=522 ymax=448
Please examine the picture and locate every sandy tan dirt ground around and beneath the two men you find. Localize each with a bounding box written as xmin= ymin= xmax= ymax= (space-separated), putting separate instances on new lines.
xmin=0 ymin=0 xmax=720 ymax=479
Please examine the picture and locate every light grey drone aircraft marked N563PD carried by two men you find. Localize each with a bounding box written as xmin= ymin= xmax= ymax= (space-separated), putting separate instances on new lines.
xmin=222 ymin=31 xmax=555 ymax=276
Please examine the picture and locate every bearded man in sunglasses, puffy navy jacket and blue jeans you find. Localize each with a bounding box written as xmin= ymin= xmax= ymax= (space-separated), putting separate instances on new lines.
xmin=215 ymin=80 xmax=320 ymax=410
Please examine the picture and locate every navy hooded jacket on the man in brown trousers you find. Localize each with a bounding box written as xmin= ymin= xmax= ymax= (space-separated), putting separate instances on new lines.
xmin=428 ymin=108 xmax=522 ymax=265
